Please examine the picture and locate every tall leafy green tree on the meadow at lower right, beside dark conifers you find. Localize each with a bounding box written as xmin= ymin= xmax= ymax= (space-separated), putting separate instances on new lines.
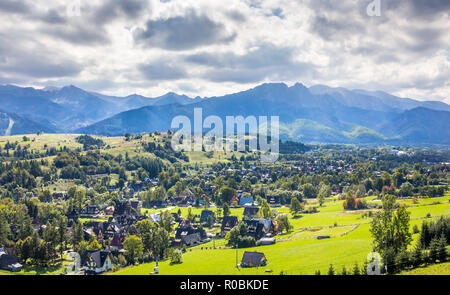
xmin=370 ymin=195 xmax=412 ymax=272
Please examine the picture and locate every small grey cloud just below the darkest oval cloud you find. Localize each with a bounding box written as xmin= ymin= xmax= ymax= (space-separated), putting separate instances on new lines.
xmin=138 ymin=59 xmax=188 ymax=80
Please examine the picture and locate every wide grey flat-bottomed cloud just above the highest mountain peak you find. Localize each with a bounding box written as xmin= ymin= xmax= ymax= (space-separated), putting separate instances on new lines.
xmin=184 ymin=44 xmax=316 ymax=83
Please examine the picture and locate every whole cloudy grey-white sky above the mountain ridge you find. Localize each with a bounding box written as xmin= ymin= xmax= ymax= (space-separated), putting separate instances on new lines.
xmin=0 ymin=0 xmax=450 ymax=103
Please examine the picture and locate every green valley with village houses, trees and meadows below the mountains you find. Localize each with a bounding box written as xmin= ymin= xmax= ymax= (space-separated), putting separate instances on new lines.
xmin=0 ymin=132 xmax=450 ymax=275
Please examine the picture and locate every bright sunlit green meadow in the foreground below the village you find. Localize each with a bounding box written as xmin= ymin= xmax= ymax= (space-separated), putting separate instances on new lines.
xmin=112 ymin=194 xmax=450 ymax=275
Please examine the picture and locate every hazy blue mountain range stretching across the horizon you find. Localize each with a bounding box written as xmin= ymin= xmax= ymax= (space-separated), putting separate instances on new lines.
xmin=0 ymin=83 xmax=450 ymax=145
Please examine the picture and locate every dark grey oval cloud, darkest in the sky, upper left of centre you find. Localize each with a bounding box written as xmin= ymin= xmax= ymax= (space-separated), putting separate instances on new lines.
xmin=134 ymin=10 xmax=236 ymax=50
